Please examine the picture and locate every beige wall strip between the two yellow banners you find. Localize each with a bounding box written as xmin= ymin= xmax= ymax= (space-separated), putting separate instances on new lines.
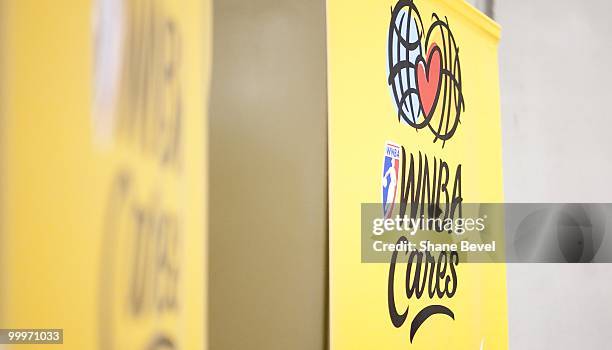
xmin=209 ymin=0 xmax=327 ymax=350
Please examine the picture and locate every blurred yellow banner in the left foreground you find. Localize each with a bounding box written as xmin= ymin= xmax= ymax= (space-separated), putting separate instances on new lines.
xmin=0 ymin=0 xmax=211 ymax=350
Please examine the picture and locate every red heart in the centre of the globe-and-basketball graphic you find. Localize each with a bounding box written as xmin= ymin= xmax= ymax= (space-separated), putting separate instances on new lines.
xmin=417 ymin=43 xmax=441 ymax=118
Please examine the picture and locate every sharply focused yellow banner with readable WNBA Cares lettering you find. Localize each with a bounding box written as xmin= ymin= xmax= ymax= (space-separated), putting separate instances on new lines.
xmin=327 ymin=0 xmax=508 ymax=350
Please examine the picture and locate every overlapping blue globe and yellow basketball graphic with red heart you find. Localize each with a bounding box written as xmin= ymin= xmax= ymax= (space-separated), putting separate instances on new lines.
xmin=387 ymin=0 xmax=465 ymax=146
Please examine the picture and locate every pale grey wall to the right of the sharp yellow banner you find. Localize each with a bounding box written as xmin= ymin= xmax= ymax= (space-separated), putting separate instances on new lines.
xmin=494 ymin=0 xmax=612 ymax=349
